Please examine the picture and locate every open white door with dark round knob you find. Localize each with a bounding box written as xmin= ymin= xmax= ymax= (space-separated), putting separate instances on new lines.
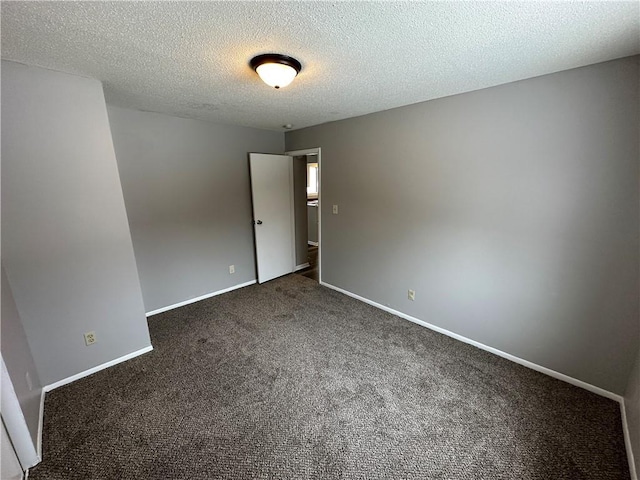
xmin=249 ymin=153 xmax=295 ymax=283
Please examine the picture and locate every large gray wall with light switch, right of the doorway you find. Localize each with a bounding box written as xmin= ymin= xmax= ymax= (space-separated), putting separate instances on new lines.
xmin=286 ymin=57 xmax=639 ymax=394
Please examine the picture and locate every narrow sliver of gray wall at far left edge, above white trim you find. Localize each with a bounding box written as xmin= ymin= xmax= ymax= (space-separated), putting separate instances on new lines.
xmin=0 ymin=267 xmax=42 ymax=446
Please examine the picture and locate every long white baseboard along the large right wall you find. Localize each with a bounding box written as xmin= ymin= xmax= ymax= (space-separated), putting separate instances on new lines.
xmin=320 ymin=281 xmax=623 ymax=403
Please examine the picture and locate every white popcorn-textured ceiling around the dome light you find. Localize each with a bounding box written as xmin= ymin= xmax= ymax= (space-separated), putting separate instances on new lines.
xmin=1 ymin=2 xmax=640 ymax=130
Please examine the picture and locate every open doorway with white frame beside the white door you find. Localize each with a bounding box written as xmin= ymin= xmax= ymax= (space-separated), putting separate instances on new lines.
xmin=286 ymin=148 xmax=321 ymax=282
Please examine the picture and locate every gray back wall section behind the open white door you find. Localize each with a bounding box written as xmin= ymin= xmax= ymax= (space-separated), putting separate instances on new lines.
xmin=109 ymin=106 xmax=284 ymax=312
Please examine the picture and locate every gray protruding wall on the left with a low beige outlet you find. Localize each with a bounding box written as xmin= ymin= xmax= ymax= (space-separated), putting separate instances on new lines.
xmin=2 ymin=61 xmax=150 ymax=385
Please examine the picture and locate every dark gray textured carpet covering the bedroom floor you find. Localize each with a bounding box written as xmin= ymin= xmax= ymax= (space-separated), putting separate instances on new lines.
xmin=30 ymin=275 xmax=629 ymax=480
